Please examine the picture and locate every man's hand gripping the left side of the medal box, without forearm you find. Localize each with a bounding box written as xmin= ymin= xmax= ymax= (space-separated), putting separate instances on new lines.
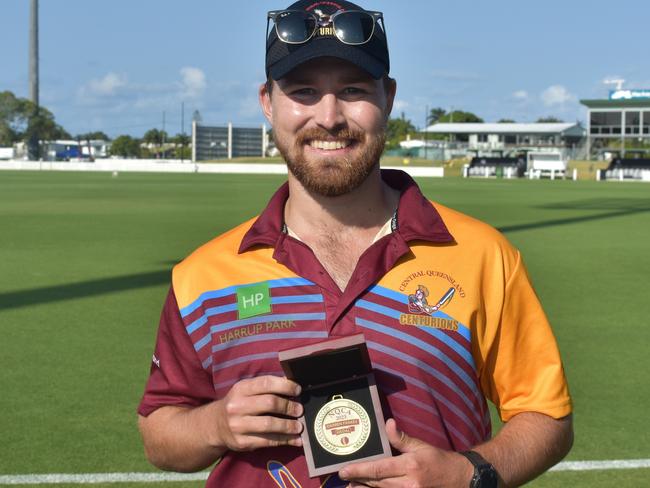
xmin=211 ymin=376 xmax=302 ymax=451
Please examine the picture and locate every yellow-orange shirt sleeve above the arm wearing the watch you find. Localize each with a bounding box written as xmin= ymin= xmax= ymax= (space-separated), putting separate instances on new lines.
xmin=479 ymin=252 xmax=572 ymax=421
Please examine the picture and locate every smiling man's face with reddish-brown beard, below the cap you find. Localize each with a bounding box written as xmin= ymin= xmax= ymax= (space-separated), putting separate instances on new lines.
xmin=260 ymin=58 xmax=395 ymax=196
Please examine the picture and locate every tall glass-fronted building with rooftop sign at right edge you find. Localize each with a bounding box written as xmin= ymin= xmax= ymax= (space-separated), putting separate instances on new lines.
xmin=580 ymin=88 xmax=650 ymax=160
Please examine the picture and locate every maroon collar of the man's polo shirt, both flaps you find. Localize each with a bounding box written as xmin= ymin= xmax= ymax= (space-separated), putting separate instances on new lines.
xmin=239 ymin=170 xmax=454 ymax=253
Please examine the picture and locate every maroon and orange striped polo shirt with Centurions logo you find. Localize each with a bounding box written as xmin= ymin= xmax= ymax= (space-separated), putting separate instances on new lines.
xmin=138 ymin=170 xmax=571 ymax=487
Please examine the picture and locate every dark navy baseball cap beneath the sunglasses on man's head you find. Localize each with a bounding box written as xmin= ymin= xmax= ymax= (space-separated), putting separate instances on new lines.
xmin=266 ymin=0 xmax=390 ymax=80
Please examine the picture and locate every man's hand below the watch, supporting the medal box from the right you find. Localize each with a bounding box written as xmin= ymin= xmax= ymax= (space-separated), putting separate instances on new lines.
xmin=339 ymin=419 xmax=474 ymax=488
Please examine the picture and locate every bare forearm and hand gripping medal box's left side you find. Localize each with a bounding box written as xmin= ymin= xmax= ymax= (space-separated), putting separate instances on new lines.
xmin=139 ymin=376 xmax=302 ymax=471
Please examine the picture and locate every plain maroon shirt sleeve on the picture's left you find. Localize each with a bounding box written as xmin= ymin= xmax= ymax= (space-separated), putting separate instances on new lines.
xmin=138 ymin=287 xmax=214 ymax=417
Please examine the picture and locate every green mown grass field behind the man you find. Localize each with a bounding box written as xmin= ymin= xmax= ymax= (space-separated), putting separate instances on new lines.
xmin=0 ymin=172 xmax=650 ymax=488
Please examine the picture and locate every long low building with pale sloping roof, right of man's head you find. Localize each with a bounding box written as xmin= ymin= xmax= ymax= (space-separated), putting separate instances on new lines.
xmin=425 ymin=123 xmax=586 ymax=159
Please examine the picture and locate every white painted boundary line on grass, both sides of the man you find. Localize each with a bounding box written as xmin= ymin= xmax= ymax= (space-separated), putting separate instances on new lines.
xmin=0 ymin=459 xmax=650 ymax=485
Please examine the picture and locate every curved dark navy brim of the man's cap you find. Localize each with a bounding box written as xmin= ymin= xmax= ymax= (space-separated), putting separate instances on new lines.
xmin=268 ymin=38 xmax=386 ymax=80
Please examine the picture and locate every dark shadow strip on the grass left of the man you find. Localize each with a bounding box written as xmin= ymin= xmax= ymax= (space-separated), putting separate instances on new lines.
xmin=0 ymin=269 xmax=171 ymax=311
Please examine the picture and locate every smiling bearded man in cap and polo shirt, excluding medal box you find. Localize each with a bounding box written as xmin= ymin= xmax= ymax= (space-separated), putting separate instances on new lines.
xmin=139 ymin=0 xmax=572 ymax=487
